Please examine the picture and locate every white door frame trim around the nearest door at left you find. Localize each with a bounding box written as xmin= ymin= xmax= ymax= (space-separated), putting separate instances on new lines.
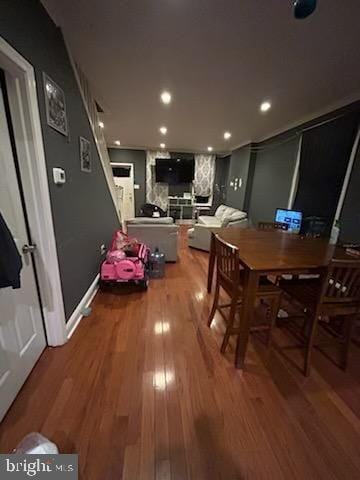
xmin=0 ymin=36 xmax=67 ymax=346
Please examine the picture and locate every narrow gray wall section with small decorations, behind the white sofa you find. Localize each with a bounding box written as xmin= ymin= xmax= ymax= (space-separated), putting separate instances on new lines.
xmin=226 ymin=145 xmax=251 ymax=210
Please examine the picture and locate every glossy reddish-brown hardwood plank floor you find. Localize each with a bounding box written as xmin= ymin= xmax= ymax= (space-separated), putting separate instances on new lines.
xmin=0 ymin=228 xmax=360 ymax=480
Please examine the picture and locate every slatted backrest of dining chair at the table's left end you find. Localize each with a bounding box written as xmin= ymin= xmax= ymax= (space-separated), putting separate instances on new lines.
xmin=215 ymin=235 xmax=240 ymax=286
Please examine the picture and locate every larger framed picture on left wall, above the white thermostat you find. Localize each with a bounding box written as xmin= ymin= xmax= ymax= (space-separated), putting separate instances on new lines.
xmin=43 ymin=73 xmax=68 ymax=136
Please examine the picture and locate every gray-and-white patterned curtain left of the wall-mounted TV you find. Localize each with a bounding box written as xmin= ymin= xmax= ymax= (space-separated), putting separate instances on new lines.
xmin=146 ymin=150 xmax=170 ymax=211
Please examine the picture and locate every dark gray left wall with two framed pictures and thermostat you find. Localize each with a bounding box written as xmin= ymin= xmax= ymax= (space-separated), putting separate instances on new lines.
xmin=0 ymin=0 xmax=118 ymax=319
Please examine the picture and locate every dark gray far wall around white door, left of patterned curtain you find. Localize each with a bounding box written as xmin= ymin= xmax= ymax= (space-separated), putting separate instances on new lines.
xmin=109 ymin=148 xmax=146 ymax=216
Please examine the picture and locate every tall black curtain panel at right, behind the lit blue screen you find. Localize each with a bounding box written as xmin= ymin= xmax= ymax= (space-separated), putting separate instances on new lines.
xmin=294 ymin=112 xmax=359 ymax=233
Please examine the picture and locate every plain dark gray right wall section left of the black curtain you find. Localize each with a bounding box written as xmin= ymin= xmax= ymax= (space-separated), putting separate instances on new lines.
xmin=249 ymin=137 xmax=299 ymax=225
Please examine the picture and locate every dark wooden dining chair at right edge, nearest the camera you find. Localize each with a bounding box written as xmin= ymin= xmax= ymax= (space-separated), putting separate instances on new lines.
xmin=280 ymin=259 xmax=360 ymax=376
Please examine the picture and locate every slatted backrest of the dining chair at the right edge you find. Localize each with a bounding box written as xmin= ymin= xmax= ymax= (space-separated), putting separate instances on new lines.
xmin=322 ymin=259 xmax=360 ymax=304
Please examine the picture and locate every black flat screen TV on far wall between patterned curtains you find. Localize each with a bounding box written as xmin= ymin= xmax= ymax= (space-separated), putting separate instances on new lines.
xmin=155 ymin=157 xmax=195 ymax=185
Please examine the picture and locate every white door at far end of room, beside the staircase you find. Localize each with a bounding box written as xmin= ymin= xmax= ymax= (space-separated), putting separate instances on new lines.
xmin=111 ymin=163 xmax=135 ymax=220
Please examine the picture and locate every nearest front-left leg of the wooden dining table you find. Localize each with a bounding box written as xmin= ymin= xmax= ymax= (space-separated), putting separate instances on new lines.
xmin=235 ymin=270 xmax=259 ymax=369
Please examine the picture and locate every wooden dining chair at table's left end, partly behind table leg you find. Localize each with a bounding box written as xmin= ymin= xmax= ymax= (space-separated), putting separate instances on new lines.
xmin=208 ymin=235 xmax=282 ymax=353
